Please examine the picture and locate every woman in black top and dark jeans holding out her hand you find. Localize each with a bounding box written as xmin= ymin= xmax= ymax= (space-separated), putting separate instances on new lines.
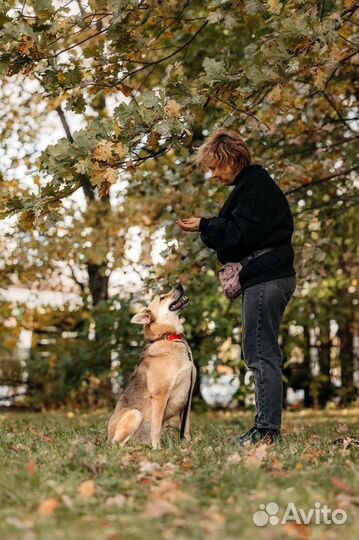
xmin=177 ymin=128 xmax=296 ymax=445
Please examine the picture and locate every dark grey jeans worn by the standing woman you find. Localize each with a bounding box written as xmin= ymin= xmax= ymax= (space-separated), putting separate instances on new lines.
xmin=242 ymin=276 xmax=296 ymax=429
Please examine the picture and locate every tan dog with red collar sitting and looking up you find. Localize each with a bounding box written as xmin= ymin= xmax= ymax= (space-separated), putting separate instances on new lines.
xmin=108 ymin=285 xmax=197 ymax=448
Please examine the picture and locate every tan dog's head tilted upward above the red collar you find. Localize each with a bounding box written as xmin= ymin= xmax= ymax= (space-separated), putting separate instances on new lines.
xmin=131 ymin=285 xmax=189 ymax=333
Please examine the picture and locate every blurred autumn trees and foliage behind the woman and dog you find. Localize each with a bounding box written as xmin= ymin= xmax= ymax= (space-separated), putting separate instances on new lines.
xmin=0 ymin=0 xmax=359 ymax=410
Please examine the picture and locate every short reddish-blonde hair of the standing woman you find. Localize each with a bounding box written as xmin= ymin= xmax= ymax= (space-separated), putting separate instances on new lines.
xmin=191 ymin=128 xmax=252 ymax=170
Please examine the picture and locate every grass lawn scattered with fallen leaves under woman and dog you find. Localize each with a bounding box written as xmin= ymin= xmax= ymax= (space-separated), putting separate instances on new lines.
xmin=0 ymin=409 xmax=359 ymax=540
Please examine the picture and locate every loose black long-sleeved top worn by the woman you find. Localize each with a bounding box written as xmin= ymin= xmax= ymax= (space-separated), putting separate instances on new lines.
xmin=200 ymin=164 xmax=295 ymax=290
